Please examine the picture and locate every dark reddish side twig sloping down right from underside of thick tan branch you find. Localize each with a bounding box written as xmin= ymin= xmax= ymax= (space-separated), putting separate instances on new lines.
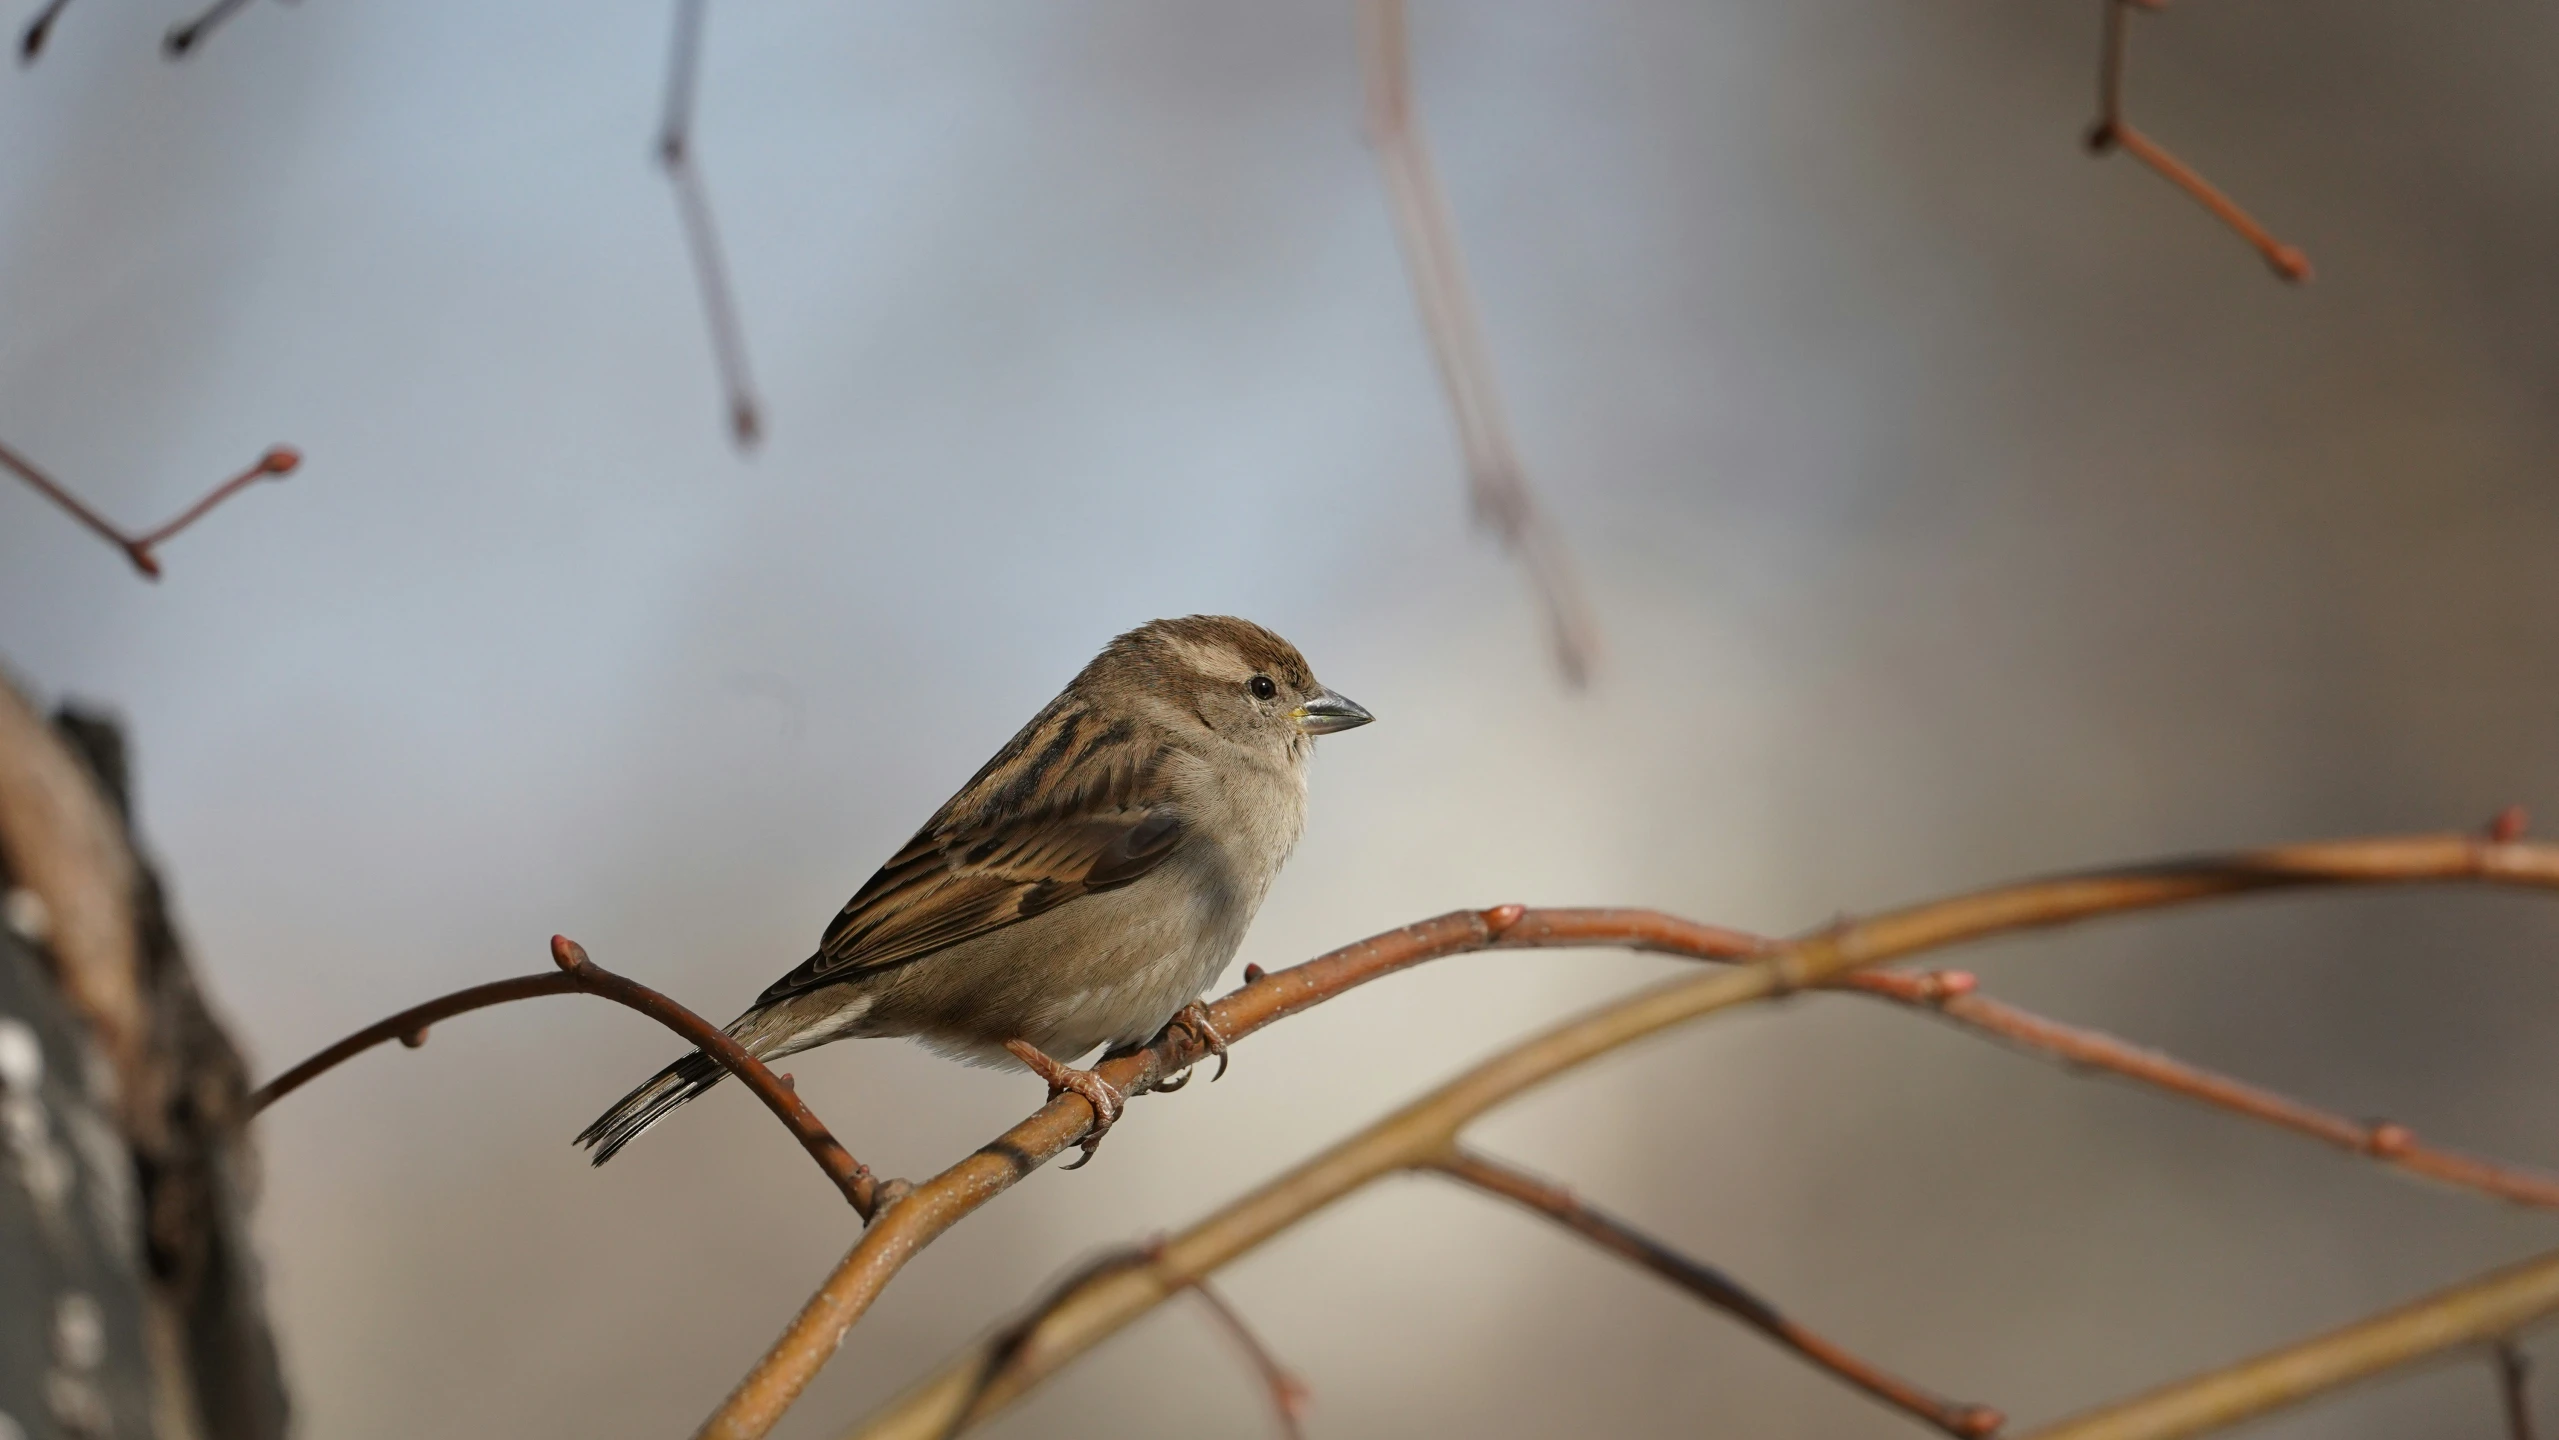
xmin=1428 ymin=1146 xmax=2006 ymax=1440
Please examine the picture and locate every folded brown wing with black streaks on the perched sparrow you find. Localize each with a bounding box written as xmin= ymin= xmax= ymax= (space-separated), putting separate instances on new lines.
xmin=757 ymin=711 xmax=1185 ymax=1005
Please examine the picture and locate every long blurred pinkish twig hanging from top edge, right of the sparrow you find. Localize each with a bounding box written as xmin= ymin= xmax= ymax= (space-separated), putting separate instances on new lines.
xmin=1359 ymin=0 xmax=1599 ymax=685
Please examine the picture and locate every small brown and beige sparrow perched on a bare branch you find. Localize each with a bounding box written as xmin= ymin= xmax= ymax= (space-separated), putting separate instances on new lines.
xmin=578 ymin=614 xmax=1372 ymax=1164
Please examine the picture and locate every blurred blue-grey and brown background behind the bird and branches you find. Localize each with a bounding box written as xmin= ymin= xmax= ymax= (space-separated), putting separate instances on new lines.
xmin=0 ymin=0 xmax=2559 ymax=1437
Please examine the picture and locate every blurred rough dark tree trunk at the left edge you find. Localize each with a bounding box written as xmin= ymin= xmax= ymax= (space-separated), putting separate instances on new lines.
xmin=0 ymin=696 xmax=287 ymax=1440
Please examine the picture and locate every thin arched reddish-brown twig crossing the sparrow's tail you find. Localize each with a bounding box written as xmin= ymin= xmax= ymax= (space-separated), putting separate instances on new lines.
xmin=248 ymin=936 xmax=901 ymax=1223
